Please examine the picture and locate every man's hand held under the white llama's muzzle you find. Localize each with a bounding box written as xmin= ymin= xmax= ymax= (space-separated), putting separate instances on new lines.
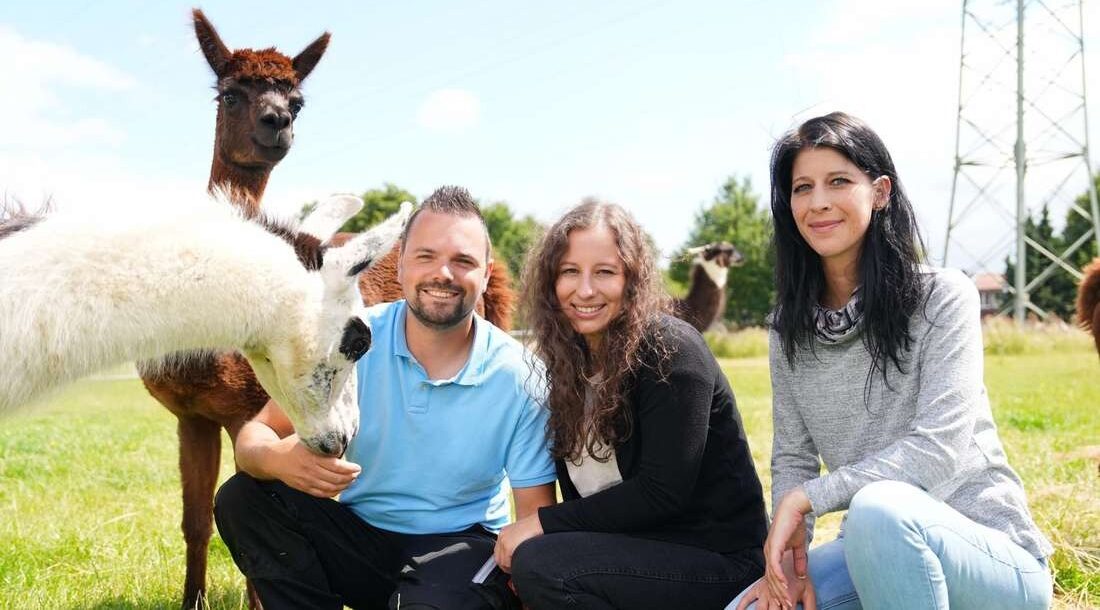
xmin=267 ymin=434 xmax=362 ymax=498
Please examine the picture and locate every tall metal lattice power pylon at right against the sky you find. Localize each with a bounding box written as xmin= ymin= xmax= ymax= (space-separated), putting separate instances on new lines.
xmin=944 ymin=0 xmax=1100 ymax=322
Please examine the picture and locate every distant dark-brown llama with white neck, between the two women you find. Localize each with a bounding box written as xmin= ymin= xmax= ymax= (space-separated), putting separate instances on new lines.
xmin=674 ymin=242 xmax=745 ymax=332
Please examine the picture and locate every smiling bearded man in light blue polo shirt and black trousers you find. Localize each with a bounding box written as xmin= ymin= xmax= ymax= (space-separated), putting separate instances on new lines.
xmin=215 ymin=187 xmax=554 ymax=610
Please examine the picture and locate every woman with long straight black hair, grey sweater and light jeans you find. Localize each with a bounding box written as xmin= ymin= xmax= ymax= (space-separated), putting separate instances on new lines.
xmin=729 ymin=112 xmax=1052 ymax=609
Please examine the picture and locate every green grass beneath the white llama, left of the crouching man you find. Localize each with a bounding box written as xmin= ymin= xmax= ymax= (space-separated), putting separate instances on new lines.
xmin=0 ymin=380 xmax=244 ymax=609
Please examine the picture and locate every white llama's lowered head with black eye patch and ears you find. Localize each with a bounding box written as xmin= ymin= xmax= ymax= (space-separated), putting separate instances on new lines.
xmin=242 ymin=196 xmax=411 ymax=455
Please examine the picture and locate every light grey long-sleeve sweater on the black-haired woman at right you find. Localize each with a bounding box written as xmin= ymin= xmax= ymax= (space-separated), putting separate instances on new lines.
xmin=770 ymin=268 xmax=1053 ymax=557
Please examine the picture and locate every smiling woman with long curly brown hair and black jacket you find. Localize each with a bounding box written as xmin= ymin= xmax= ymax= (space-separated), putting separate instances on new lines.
xmin=496 ymin=200 xmax=766 ymax=610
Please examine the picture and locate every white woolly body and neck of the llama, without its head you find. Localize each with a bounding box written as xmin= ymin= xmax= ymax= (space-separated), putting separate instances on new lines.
xmin=0 ymin=209 xmax=310 ymax=412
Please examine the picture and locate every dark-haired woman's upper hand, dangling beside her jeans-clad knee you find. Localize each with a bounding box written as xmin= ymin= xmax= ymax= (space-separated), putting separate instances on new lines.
xmin=763 ymin=486 xmax=813 ymax=608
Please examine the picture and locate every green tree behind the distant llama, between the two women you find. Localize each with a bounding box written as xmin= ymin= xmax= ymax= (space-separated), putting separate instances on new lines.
xmin=669 ymin=176 xmax=776 ymax=324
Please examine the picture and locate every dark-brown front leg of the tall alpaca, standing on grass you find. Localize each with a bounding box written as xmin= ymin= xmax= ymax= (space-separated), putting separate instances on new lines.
xmin=176 ymin=417 xmax=221 ymax=609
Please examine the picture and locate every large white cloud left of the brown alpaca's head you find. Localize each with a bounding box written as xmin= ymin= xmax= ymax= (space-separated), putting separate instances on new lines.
xmin=0 ymin=25 xmax=176 ymax=219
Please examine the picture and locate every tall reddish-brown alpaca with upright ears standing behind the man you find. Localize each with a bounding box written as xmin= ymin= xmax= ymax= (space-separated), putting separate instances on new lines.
xmin=139 ymin=9 xmax=515 ymax=608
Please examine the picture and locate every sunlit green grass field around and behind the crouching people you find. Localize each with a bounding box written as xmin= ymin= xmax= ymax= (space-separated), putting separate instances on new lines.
xmin=0 ymin=329 xmax=1100 ymax=609
